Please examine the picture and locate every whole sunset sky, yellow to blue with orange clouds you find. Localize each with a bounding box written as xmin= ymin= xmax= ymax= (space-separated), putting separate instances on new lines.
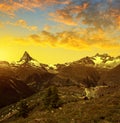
xmin=0 ymin=0 xmax=120 ymax=64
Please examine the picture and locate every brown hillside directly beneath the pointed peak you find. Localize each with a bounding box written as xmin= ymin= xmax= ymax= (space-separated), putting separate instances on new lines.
xmin=15 ymin=64 xmax=54 ymax=90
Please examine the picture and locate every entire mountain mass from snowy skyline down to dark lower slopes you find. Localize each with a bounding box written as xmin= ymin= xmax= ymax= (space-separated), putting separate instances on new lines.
xmin=0 ymin=51 xmax=120 ymax=107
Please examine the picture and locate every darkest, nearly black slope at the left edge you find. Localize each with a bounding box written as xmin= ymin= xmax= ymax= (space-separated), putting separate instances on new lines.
xmin=0 ymin=76 xmax=33 ymax=108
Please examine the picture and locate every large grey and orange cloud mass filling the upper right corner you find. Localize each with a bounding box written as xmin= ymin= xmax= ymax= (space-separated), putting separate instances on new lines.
xmin=49 ymin=0 xmax=120 ymax=30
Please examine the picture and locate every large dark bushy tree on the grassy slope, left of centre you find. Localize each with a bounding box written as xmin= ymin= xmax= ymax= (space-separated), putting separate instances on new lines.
xmin=43 ymin=86 xmax=62 ymax=109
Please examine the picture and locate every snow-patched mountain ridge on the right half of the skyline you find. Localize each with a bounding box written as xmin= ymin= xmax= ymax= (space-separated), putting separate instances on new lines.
xmin=56 ymin=53 xmax=120 ymax=69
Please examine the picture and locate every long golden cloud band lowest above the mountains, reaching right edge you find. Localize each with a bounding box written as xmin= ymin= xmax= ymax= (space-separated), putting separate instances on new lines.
xmin=29 ymin=29 xmax=120 ymax=50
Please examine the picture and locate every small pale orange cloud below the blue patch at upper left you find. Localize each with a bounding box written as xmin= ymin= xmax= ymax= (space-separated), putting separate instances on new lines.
xmin=7 ymin=19 xmax=38 ymax=31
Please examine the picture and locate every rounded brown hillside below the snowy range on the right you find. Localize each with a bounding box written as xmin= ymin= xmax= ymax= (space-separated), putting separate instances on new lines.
xmin=50 ymin=64 xmax=100 ymax=87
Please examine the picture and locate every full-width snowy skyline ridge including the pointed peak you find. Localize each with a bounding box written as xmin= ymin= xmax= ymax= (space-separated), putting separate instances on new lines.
xmin=0 ymin=51 xmax=120 ymax=70
